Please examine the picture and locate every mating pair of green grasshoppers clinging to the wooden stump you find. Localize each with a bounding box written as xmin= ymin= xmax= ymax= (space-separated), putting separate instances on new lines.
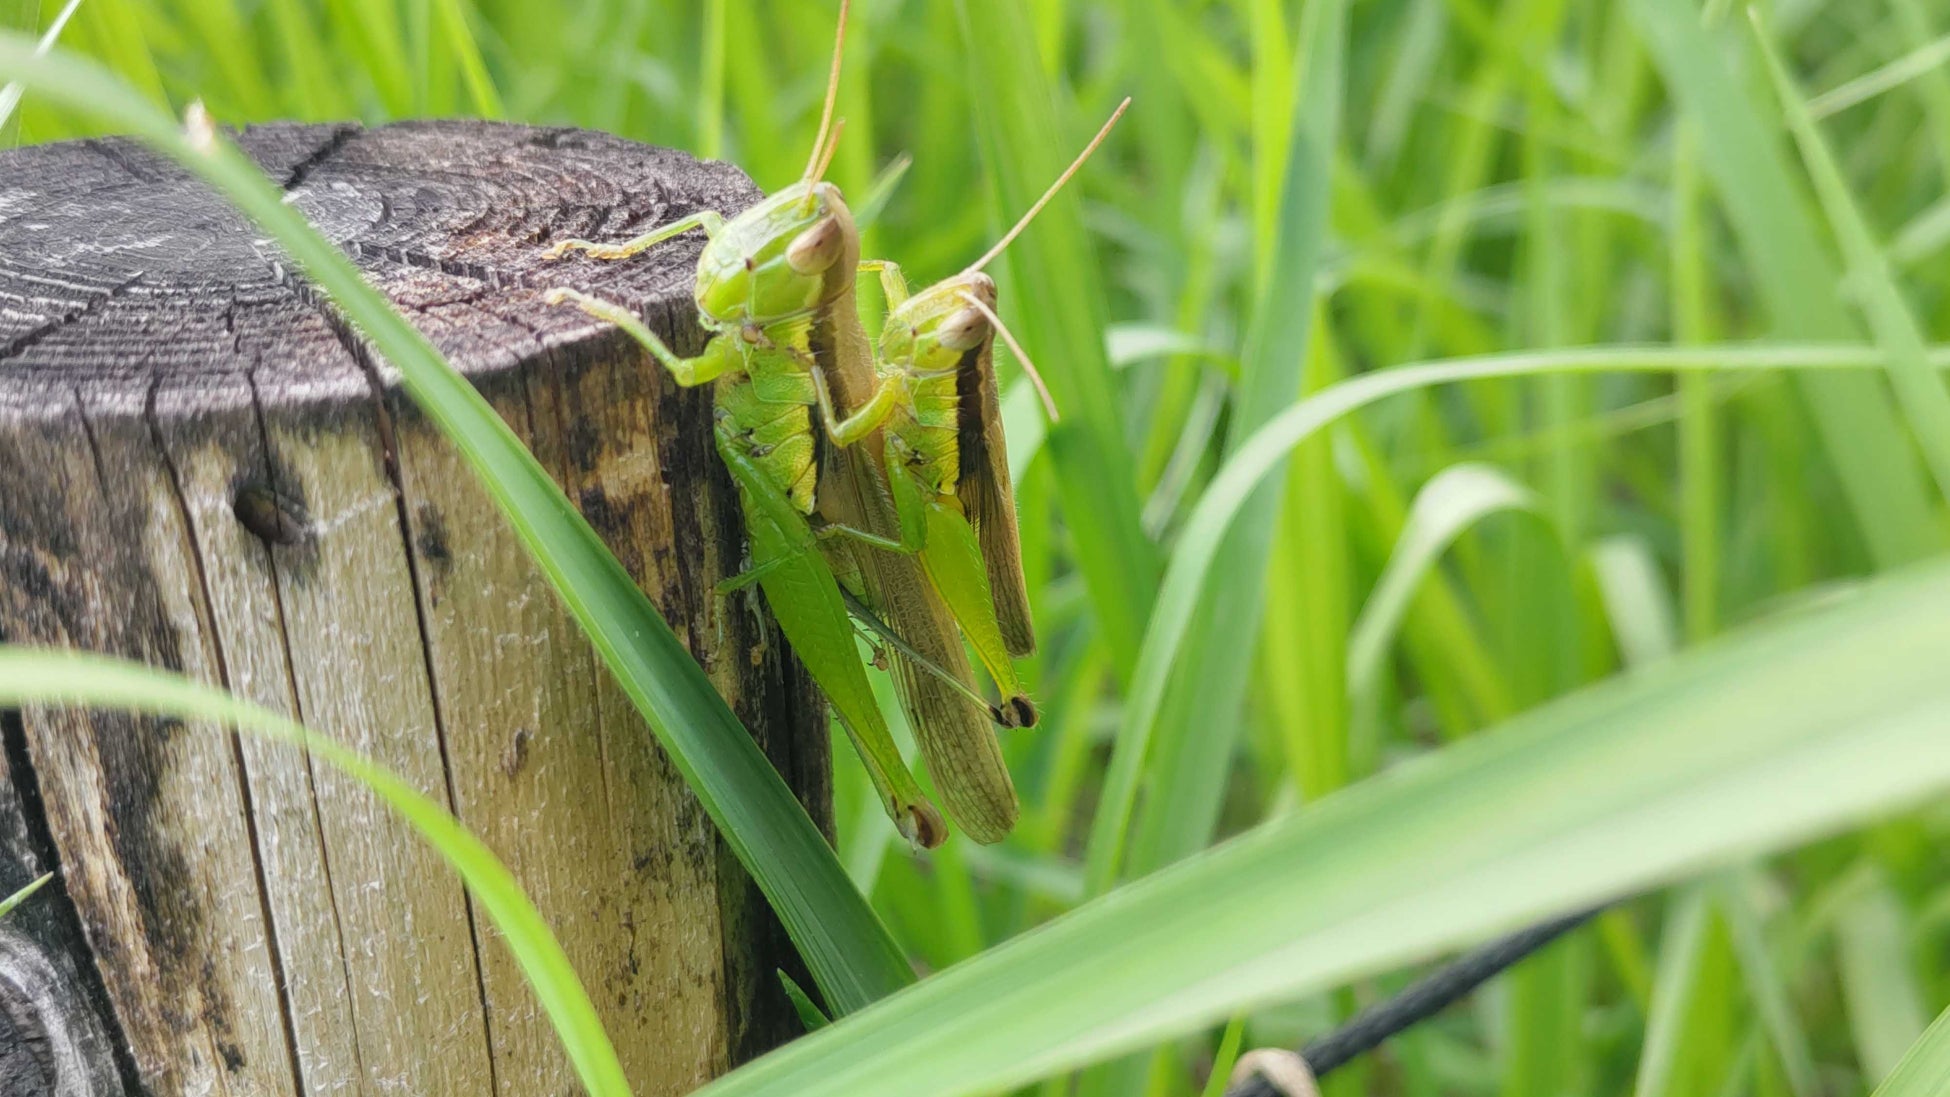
xmin=548 ymin=0 xmax=1123 ymax=848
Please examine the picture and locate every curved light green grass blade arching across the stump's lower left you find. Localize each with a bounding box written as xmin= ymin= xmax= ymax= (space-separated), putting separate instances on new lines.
xmin=0 ymin=650 xmax=630 ymax=1097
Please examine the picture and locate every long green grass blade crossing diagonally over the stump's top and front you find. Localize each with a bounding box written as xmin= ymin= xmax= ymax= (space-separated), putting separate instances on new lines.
xmin=0 ymin=35 xmax=915 ymax=1013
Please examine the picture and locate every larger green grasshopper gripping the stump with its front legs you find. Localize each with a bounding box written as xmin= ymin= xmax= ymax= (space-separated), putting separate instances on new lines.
xmin=546 ymin=0 xmax=1016 ymax=846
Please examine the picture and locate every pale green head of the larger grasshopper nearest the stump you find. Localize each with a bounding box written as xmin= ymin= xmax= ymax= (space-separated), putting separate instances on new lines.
xmin=696 ymin=181 xmax=860 ymax=323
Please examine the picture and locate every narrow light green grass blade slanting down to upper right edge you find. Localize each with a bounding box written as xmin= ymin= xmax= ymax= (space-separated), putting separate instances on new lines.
xmin=1753 ymin=14 xmax=1950 ymax=495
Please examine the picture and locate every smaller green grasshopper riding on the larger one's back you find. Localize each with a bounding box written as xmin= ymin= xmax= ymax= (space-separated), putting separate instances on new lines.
xmin=813 ymin=99 xmax=1131 ymax=725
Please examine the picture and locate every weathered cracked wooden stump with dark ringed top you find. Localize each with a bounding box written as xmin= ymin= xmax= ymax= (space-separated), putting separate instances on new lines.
xmin=0 ymin=123 xmax=829 ymax=1097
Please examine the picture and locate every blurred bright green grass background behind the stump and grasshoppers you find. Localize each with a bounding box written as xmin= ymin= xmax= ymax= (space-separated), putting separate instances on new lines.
xmin=15 ymin=0 xmax=1950 ymax=1097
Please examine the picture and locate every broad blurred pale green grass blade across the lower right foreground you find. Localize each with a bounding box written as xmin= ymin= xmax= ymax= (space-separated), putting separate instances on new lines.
xmin=700 ymin=567 xmax=1950 ymax=1097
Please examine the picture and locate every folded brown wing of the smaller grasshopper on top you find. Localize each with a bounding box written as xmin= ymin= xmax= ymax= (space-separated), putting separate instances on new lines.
xmin=956 ymin=335 xmax=1035 ymax=657
